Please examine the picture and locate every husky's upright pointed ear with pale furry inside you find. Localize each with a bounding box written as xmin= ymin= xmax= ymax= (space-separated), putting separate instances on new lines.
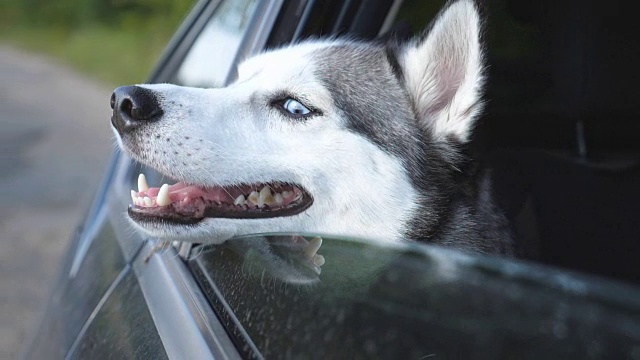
xmin=398 ymin=0 xmax=483 ymax=142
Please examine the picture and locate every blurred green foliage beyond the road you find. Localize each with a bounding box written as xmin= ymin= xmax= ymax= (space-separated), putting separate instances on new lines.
xmin=0 ymin=0 xmax=194 ymax=85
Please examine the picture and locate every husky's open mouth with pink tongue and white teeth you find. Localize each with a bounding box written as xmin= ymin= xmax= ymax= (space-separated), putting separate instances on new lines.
xmin=129 ymin=174 xmax=313 ymax=224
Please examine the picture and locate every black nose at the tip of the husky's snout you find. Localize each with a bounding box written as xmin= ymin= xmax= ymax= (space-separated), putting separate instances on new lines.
xmin=111 ymin=86 xmax=162 ymax=135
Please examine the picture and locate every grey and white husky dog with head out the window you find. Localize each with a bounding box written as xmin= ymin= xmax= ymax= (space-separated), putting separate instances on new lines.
xmin=111 ymin=0 xmax=513 ymax=254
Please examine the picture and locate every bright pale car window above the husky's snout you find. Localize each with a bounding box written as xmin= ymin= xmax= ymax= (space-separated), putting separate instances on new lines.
xmin=173 ymin=0 xmax=258 ymax=87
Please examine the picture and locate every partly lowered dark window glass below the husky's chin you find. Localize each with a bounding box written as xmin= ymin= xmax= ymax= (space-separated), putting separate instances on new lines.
xmin=190 ymin=235 xmax=640 ymax=359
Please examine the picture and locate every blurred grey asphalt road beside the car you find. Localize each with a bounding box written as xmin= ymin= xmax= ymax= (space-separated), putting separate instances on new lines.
xmin=0 ymin=44 xmax=112 ymax=359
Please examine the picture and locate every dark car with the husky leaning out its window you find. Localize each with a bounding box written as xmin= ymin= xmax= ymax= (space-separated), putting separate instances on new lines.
xmin=26 ymin=0 xmax=640 ymax=359
